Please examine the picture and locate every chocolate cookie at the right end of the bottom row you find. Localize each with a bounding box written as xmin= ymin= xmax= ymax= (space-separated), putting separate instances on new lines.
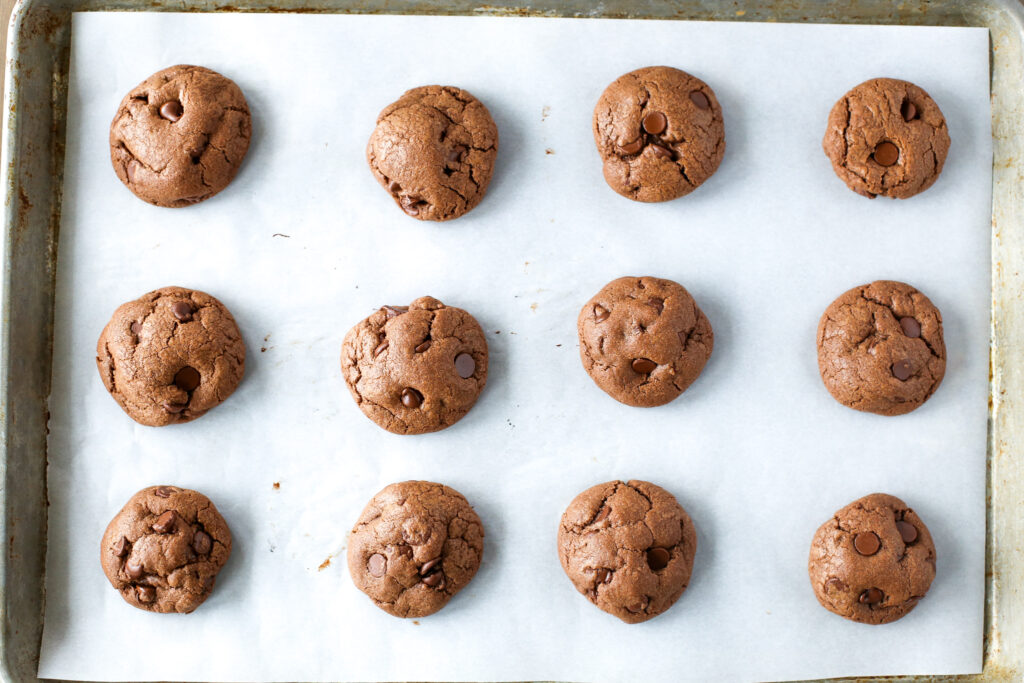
xmin=807 ymin=494 xmax=935 ymax=624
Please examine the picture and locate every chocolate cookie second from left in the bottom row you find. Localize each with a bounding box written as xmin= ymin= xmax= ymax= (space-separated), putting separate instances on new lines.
xmin=348 ymin=481 xmax=483 ymax=618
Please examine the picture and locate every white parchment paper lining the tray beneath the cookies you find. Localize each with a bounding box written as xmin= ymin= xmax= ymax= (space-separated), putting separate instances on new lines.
xmin=39 ymin=13 xmax=991 ymax=681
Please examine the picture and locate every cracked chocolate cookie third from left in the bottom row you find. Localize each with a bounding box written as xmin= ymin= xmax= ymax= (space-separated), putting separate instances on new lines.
xmin=558 ymin=481 xmax=697 ymax=624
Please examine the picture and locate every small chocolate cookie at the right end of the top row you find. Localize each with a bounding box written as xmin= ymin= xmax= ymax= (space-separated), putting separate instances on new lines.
xmin=821 ymin=78 xmax=949 ymax=200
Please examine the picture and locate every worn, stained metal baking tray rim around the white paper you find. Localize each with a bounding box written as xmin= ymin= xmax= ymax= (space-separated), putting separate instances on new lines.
xmin=0 ymin=0 xmax=1024 ymax=683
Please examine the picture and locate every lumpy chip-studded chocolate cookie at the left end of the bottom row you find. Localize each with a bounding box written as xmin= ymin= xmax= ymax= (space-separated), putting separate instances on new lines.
xmin=99 ymin=486 xmax=231 ymax=613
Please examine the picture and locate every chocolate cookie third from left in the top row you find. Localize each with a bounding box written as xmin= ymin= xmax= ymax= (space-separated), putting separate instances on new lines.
xmin=594 ymin=67 xmax=725 ymax=202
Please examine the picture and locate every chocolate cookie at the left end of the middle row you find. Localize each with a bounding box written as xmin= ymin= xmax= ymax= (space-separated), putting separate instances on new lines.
xmin=96 ymin=287 xmax=246 ymax=427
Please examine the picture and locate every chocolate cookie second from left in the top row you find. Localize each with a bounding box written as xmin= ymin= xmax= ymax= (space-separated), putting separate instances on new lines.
xmin=367 ymin=85 xmax=498 ymax=220
